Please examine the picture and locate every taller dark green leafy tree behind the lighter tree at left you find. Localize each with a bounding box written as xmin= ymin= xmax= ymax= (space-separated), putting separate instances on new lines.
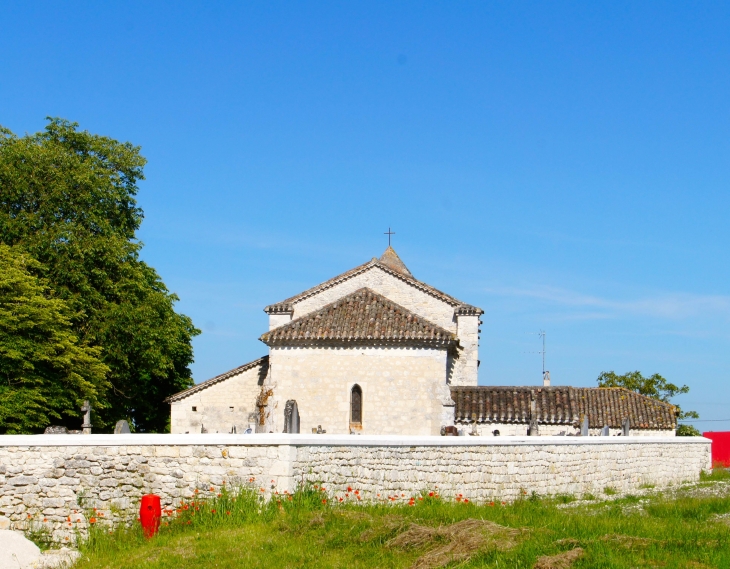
xmin=0 ymin=119 xmax=199 ymax=431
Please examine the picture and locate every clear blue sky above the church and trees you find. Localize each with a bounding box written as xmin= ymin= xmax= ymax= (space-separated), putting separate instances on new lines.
xmin=0 ymin=0 xmax=730 ymax=430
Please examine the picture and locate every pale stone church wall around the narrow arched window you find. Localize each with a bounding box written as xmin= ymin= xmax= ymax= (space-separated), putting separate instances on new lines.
xmin=266 ymin=347 xmax=453 ymax=435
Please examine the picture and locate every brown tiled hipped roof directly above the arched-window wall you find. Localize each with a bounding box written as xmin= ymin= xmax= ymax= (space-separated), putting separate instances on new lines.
xmin=260 ymin=288 xmax=458 ymax=346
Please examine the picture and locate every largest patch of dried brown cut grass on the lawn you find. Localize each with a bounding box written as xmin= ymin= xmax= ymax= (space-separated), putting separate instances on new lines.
xmin=386 ymin=519 xmax=526 ymax=569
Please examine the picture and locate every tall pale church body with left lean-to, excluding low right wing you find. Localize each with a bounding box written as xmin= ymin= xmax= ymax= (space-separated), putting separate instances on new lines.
xmin=168 ymin=246 xmax=483 ymax=435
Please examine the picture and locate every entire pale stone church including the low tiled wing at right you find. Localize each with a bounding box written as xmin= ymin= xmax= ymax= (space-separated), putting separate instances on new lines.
xmin=167 ymin=246 xmax=676 ymax=436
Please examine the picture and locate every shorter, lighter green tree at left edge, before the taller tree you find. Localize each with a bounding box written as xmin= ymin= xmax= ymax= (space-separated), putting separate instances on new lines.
xmin=0 ymin=244 xmax=108 ymax=433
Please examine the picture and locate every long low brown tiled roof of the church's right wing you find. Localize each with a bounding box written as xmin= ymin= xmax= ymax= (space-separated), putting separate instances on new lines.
xmin=451 ymin=386 xmax=676 ymax=430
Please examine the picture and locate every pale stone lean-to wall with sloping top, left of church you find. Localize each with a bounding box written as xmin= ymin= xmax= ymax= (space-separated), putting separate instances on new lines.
xmin=170 ymin=366 xmax=261 ymax=434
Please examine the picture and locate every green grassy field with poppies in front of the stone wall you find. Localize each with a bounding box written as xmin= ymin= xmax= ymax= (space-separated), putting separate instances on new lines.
xmin=75 ymin=470 xmax=730 ymax=569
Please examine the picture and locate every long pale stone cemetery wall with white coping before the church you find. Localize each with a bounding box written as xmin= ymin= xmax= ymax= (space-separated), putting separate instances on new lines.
xmin=0 ymin=434 xmax=711 ymax=542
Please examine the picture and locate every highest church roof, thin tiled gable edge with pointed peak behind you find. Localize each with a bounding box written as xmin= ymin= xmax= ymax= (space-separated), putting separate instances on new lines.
xmin=264 ymin=245 xmax=484 ymax=314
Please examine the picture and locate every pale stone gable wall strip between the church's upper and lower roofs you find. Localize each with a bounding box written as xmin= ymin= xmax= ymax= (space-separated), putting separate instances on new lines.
xmin=294 ymin=267 xmax=457 ymax=332
